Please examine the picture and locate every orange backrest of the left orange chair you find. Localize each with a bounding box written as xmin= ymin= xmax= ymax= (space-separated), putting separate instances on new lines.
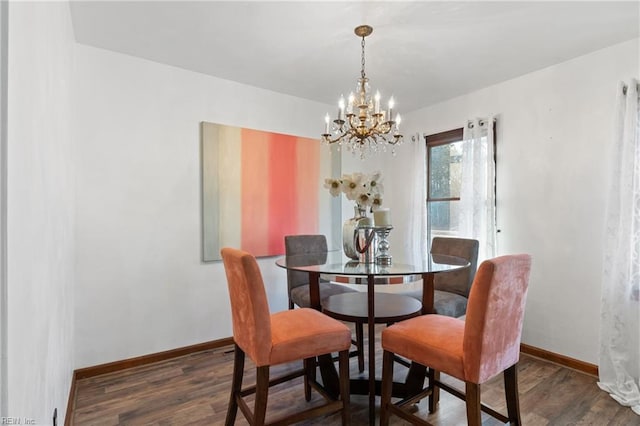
xmin=220 ymin=248 xmax=271 ymax=366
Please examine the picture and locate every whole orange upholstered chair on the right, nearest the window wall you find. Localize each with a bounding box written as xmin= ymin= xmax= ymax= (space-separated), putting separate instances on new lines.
xmin=380 ymin=254 xmax=531 ymax=426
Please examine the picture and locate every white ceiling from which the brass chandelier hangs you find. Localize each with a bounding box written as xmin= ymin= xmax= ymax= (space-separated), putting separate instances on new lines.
xmin=71 ymin=0 xmax=640 ymax=112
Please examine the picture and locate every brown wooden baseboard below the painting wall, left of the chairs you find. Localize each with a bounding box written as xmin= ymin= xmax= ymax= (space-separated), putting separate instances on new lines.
xmin=64 ymin=337 xmax=233 ymax=426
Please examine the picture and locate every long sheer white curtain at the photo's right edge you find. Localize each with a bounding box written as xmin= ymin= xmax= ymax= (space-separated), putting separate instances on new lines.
xmin=598 ymin=79 xmax=640 ymax=415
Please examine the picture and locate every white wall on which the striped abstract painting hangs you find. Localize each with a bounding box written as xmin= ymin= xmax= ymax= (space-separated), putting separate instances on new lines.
xmin=75 ymin=45 xmax=327 ymax=368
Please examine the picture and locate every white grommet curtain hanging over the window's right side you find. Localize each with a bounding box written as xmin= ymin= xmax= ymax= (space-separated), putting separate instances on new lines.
xmin=458 ymin=117 xmax=496 ymax=264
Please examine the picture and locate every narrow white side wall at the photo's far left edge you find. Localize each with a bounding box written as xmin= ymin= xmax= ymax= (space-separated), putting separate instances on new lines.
xmin=2 ymin=2 xmax=75 ymax=424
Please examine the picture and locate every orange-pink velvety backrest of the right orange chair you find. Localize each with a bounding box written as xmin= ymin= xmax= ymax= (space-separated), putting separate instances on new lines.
xmin=463 ymin=254 xmax=531 ymax=383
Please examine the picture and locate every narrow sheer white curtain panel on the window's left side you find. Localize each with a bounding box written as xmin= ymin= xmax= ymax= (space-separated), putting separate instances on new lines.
xmin=403 ymin=134 xmax=428 ymax=265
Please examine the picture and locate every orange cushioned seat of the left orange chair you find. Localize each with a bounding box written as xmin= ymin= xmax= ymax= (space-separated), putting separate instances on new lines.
xmin=268 ymin=308 xmax=351 ymax=365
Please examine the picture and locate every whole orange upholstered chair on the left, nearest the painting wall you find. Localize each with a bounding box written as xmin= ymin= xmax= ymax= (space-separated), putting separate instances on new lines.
xmin=221 ymin=248 xmax=351 ymax=425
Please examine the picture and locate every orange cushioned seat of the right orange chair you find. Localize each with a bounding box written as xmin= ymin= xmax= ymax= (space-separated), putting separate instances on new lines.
xmin=382 ymin=315 xmax=465 ymax=379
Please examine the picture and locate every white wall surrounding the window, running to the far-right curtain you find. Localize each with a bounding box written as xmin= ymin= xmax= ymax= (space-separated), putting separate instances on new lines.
xmin=392 ymin=40 xmax=640 ymax=363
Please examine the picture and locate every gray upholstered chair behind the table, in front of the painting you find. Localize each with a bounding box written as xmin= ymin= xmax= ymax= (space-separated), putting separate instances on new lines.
xmin=284 ymin=235 xmax=364 ymax=372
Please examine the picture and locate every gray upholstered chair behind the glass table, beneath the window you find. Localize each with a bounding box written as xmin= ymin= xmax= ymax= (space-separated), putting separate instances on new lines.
xmin=403 ymin=237 xmax=479 ymax=318
